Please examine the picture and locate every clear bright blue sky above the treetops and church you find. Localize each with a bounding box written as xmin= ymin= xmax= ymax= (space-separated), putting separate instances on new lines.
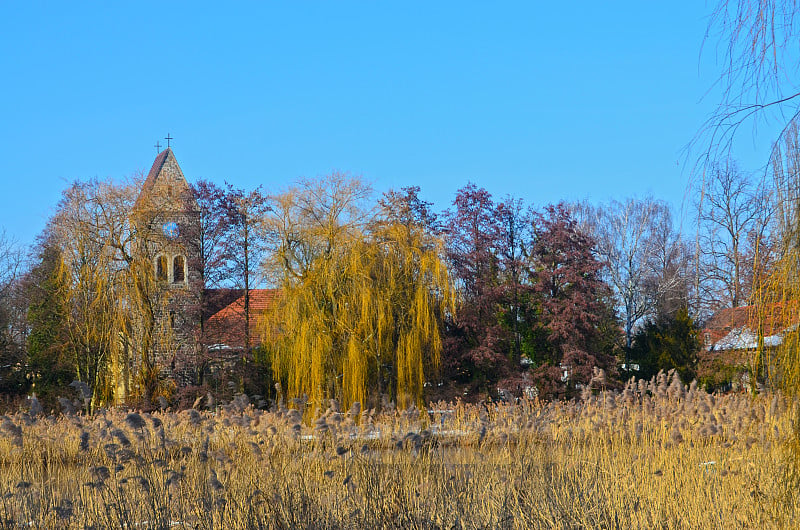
xmin=0 ymin=0 xmax=780 ymax=243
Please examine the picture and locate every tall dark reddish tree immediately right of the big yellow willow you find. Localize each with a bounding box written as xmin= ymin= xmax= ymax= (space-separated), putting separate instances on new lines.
xmin=444 ymin=184 xmax=534 ymax=393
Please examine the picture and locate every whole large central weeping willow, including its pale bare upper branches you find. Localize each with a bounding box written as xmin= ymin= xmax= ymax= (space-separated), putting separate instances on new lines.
xmin=263 ymin=174 xmax=454 ymax=406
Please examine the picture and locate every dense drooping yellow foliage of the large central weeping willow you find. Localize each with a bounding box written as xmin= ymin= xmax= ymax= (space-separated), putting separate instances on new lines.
xmin=262 ymin=224 xmax=455 ymax=407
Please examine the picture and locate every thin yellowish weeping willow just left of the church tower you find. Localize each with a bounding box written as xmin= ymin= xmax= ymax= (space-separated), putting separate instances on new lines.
xmin=49 ymin=180 xmax=178 ymax=405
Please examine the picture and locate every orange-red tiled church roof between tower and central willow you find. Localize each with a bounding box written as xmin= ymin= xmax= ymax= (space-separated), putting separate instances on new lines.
xmin=205 ymin=289 xmax=280 ymax=349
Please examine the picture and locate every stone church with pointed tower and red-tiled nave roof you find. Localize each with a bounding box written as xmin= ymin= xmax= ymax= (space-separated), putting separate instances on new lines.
xmin=126 ymin=147 xmax=275 ymax=393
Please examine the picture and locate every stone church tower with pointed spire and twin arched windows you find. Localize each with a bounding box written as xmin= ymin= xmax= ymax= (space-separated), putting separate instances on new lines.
xmin=131 ymin=147 xmax=203 ymax=384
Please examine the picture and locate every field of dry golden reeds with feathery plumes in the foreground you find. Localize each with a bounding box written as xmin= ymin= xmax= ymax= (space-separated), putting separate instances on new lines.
xmin=0 ymin=370 xmax=800 ymax=529
